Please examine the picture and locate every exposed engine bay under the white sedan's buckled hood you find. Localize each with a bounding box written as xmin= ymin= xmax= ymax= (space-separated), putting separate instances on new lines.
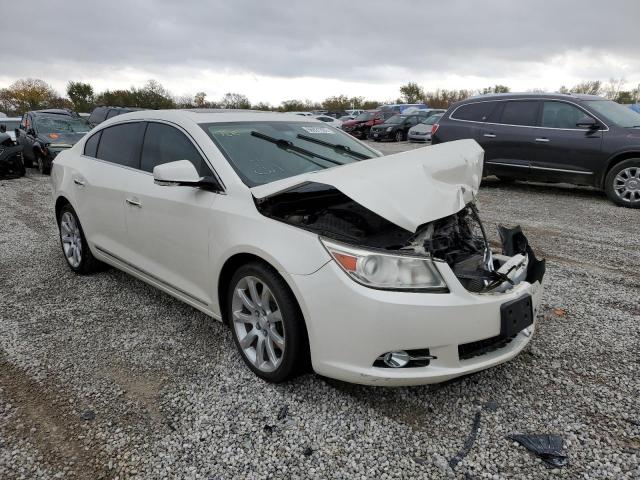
xmin=257 ymin=183 xmax=545 ymax=293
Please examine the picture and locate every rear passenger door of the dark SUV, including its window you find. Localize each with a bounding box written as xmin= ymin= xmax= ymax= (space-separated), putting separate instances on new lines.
xmin=478 ymin=100 xmax=541 ymax=178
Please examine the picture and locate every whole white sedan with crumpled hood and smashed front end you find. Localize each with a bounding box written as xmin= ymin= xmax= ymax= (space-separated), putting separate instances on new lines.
xmin=51 ymin=110 xmax=544 ymax=385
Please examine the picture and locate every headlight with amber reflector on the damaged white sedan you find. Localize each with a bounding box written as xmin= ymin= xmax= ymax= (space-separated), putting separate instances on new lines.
xmin=320 ymin=238 xmax=447 ymax=290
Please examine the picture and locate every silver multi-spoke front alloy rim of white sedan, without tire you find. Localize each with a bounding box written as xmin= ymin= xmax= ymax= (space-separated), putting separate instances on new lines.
xmin=231 ymin=276 xmax=286 ymax=372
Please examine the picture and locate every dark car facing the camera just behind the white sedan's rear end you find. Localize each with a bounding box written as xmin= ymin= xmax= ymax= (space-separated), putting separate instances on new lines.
xmin=16 ymin=109 xmax=91 ymax=174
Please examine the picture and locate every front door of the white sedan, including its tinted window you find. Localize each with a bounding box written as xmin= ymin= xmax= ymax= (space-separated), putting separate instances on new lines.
xmin=125 ymin=122 xmax=218 ymax=308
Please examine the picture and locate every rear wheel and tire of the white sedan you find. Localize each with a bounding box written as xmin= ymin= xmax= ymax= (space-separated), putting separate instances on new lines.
xmin=58 ymin=203 xmax=103 ymax=275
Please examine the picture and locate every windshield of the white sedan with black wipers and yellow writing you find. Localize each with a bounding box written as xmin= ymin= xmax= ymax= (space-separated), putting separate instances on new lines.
xmin=200 ymin=121 xmax=378 ymax=187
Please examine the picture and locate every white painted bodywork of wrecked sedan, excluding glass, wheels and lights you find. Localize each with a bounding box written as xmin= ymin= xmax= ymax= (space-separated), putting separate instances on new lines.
xmin=52 ymin=111 xmax=542 ymax=385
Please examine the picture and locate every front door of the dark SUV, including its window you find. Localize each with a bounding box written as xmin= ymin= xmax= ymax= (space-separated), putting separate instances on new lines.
xmin=531 ymin=100 xmax=603 ymax=185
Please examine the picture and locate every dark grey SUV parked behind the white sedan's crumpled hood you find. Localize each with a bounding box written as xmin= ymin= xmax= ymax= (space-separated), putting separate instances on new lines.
xmin=432 ymin=93 xmax=640 ymax=208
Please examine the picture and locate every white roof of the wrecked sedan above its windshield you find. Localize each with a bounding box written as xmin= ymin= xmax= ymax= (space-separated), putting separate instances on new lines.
xmin=101 ymin=108 xmax=330 ymax=125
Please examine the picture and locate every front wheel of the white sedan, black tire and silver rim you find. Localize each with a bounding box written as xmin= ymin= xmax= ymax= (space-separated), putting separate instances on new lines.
xmin=225 ymin=261 xmax=309 ymax=383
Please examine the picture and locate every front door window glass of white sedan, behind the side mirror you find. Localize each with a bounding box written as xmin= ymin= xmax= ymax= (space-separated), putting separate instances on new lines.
xmin=140 ymin=123 xmax=205 ymax=176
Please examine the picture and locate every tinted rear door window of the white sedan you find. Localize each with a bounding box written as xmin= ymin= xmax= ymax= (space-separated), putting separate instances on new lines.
xmin=97 ymin=122 xmax=143 ymax=168
